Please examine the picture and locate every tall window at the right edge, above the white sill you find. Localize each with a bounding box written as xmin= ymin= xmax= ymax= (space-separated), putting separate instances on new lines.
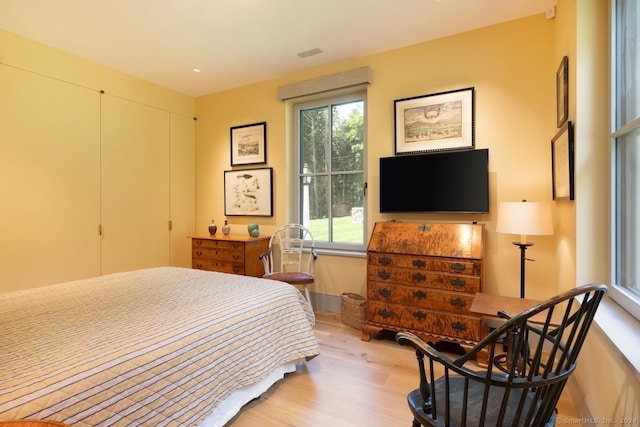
xmin=611 ymin=0 xmax=640 ymax=318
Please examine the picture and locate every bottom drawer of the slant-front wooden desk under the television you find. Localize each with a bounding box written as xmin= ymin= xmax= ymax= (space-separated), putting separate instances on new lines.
xmin=367 ymin=301 xmax=486 ymax=341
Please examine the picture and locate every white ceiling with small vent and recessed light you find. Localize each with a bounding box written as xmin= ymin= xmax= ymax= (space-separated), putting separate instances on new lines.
xmin=0 ymin=0 xmax=556 ymax=96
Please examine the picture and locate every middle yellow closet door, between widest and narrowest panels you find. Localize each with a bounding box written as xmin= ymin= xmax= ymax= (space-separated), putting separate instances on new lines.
xmin=101 ymin=94 xmax=171 ymax=274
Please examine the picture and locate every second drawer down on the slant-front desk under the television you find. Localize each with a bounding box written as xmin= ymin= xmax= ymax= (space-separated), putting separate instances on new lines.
xmin=367 ymin=266 xmax=481 ymax=294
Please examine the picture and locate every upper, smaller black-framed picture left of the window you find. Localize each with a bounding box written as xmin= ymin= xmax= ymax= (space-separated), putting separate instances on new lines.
xmin=231 ymin=122 xmax=267 ymax=166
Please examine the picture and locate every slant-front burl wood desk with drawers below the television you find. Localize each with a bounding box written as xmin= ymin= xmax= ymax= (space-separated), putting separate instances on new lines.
xmin=362 ymin=222 xmax=488 ymax=349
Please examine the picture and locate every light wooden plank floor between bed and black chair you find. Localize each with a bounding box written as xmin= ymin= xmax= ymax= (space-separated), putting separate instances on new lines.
xmin=227 ymin=313 xmax=579 ymax=427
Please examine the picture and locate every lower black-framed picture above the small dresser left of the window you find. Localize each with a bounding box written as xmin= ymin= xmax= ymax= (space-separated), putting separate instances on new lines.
xmin=224 ymin=168 xmax=273 ymax=216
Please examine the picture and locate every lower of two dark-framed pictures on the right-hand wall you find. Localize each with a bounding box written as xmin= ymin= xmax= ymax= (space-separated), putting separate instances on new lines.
xmin=551 ymin=121 xmax=574 ymax=200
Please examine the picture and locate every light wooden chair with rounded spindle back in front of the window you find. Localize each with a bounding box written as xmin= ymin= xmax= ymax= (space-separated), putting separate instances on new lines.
xmin=260 ymin=224 xmax=318 ymax=303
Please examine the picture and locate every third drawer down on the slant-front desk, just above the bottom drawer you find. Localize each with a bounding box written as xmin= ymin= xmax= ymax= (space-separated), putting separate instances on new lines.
xmin=367 ymin=282 xmax=473 ymax=313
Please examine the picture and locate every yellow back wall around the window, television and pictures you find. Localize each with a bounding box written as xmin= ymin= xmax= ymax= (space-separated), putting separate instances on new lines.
xmin=196 ymin=14 xmax=558 ymax=298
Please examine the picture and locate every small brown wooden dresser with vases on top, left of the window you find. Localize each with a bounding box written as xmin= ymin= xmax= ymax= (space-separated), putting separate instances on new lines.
xmin=191 ymin=234 xmax=269 ymax=277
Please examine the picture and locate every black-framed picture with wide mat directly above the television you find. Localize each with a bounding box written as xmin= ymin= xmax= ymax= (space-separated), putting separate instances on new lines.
xmin=394 ymin=87 xmax=475 ymax=154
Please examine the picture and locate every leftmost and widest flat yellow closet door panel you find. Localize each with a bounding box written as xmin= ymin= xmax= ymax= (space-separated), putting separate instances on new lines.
xmin=0 ymin=64 xmax=100 ymax=291
